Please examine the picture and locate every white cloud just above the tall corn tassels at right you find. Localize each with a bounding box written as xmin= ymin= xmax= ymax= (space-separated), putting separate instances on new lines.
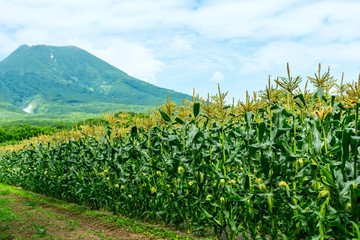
xmin=240 ymin=41 xmax=360 ymax=73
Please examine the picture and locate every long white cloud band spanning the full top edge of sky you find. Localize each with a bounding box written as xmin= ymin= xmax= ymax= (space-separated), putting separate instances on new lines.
xmin=0 ymin=0 xmax=360 ymax=43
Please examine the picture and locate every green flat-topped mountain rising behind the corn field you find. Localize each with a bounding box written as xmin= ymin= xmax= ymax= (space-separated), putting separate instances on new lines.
xmin=0 ymin=45 xmax=190 ymax=114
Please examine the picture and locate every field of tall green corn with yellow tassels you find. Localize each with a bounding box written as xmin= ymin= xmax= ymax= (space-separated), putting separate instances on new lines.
xmin=0 ymin=65 xmax=360 ymax=239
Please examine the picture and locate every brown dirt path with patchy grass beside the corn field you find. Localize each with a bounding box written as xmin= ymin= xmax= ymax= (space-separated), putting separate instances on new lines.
xmin=0 ymin=188 xmax=170 ymax=240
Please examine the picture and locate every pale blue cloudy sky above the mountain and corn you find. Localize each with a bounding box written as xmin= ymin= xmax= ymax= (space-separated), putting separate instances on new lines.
xmin=0 ymin=0 xmax=360 ymax=101
